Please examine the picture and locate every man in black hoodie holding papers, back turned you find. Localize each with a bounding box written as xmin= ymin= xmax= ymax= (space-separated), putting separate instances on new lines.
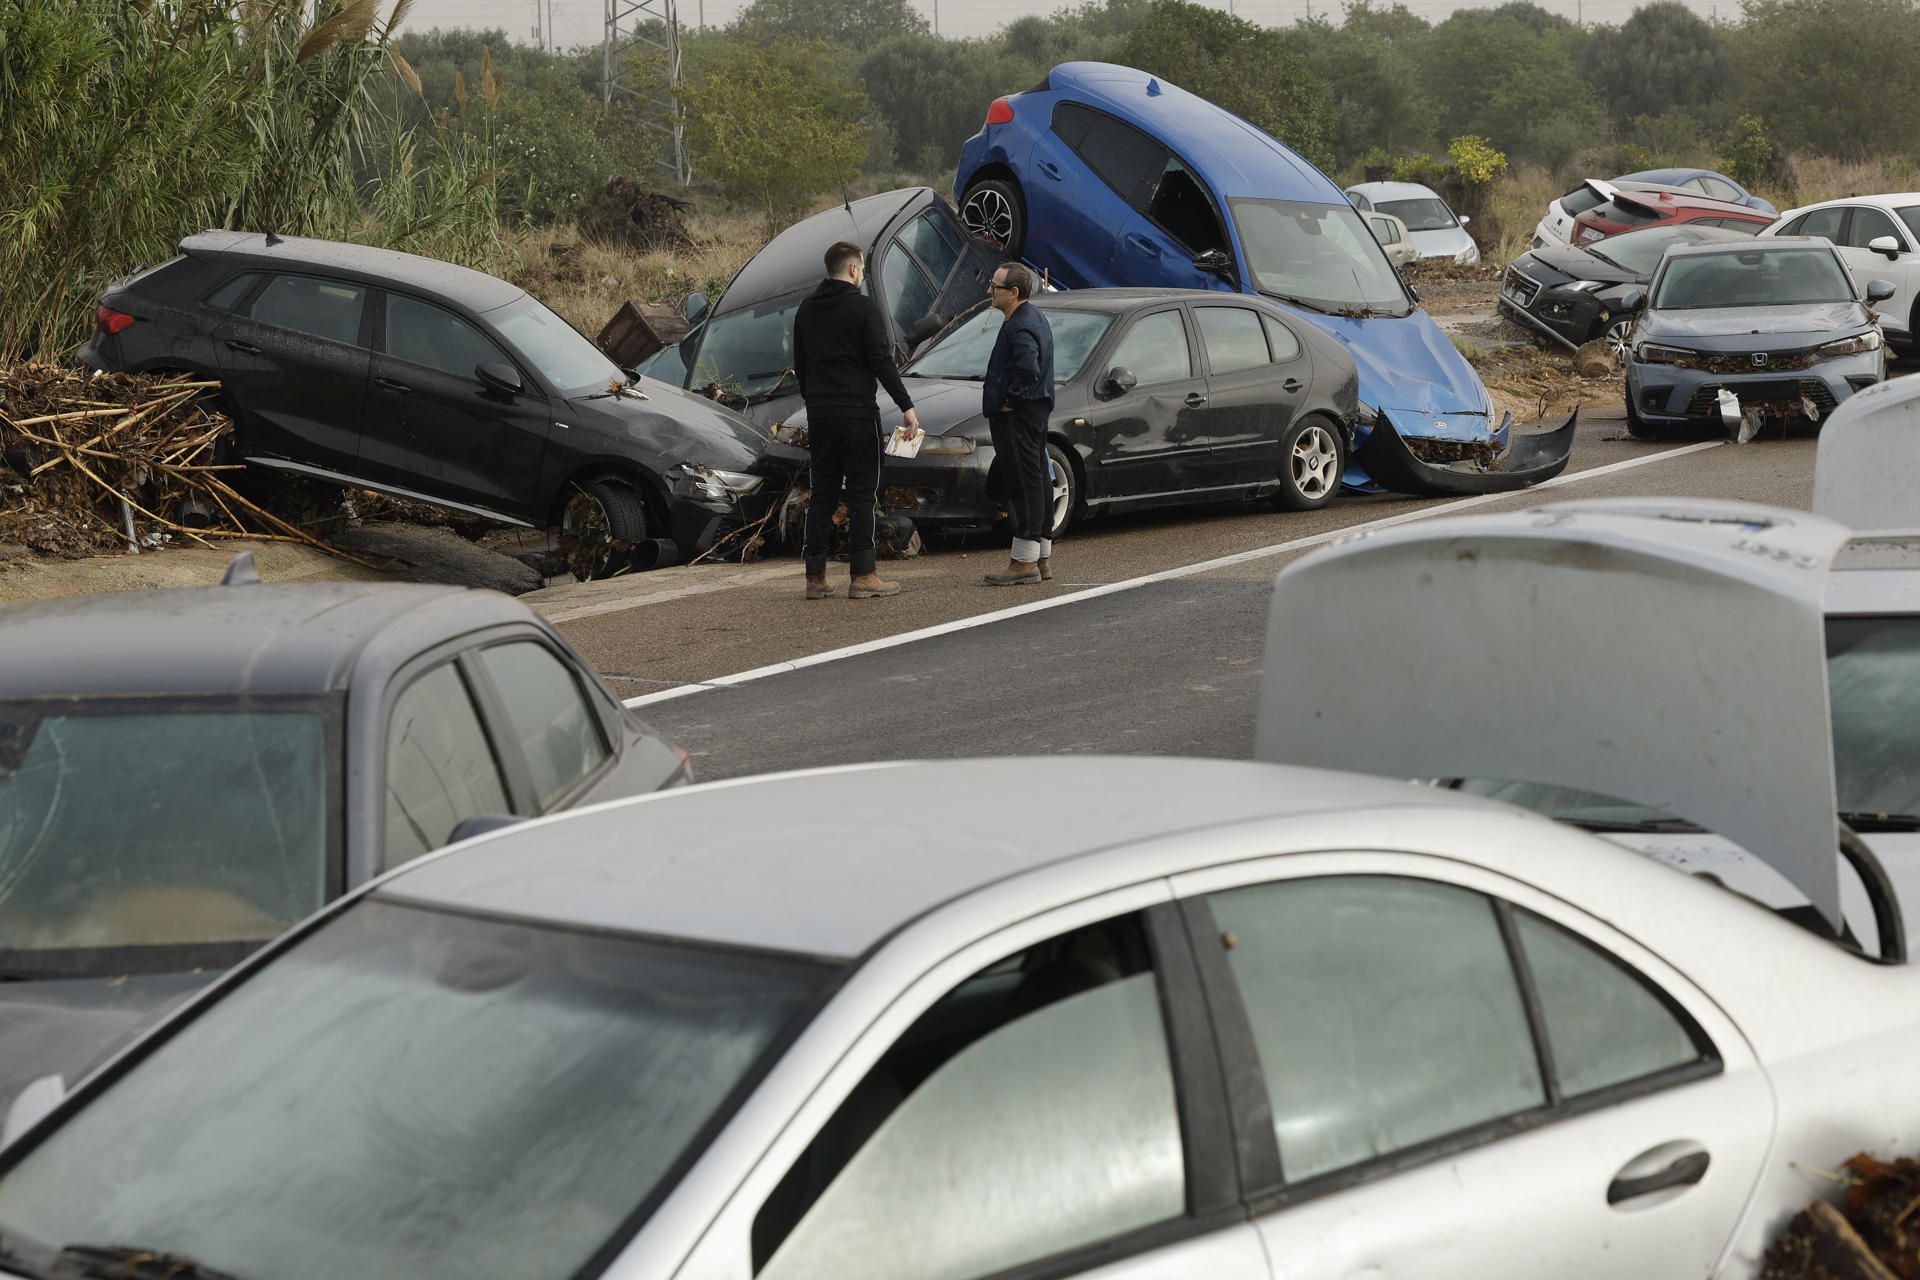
xmin=793 ymin=240 xmax=920 ymax=601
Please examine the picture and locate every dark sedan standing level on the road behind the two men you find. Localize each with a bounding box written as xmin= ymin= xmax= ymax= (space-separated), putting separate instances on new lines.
xmin=778 ymin=290 xmax=1359 ymax=533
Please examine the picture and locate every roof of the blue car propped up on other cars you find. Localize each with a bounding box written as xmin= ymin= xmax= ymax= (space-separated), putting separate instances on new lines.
xmin=1046 ymin=61 xmax=1348 ymax=203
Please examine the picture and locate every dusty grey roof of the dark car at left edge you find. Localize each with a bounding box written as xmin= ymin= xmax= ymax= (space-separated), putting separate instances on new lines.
xmin=0 ymin=581 xmax=530 ymax=699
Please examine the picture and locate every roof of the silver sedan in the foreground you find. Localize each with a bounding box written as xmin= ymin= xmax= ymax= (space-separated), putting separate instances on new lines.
xmin=376 ymin=756 xmax=1500 ymax=958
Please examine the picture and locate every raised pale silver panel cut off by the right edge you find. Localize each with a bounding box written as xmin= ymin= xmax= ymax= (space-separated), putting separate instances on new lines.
xmin=1812 ymin=374 xmax=1920 ymax=533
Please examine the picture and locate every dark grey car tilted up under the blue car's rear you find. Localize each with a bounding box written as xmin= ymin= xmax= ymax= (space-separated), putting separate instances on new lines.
xmin=641 ymin=186 xmax=1006 ymax=422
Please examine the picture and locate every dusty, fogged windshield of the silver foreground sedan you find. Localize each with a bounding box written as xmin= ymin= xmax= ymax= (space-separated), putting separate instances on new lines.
xmin=0 ymin=900 xmax=833 ymax=1280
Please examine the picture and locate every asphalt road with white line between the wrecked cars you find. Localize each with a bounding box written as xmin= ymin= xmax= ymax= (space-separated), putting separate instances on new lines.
xmin=524 ymin=405 xmax=1814 ymax=779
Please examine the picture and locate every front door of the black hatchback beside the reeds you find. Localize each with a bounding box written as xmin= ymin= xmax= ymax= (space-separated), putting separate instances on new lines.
xmin=355 ymin=292 xmax=553 ymax=520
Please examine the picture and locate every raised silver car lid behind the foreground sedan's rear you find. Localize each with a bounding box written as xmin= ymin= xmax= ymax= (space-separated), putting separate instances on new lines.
xmin=1254 ymin=499 xmax=1847 ymax=927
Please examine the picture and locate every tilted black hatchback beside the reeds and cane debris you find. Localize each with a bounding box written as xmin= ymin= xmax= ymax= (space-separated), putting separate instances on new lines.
xmin=79 ymin=230 xmax=781 ymax=578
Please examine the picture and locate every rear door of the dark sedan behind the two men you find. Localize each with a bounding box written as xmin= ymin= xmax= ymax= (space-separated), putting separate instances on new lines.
xmin=1192 ymin=303 xmax=1311 ymax=487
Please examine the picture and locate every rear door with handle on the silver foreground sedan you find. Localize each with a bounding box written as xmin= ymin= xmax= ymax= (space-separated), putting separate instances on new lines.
xmin=1175 ymin=852 xmax=1774 ymax=1280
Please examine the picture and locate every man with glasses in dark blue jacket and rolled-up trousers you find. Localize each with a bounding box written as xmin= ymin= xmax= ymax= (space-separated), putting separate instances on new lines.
xmin=981 ymin=263 xmax=1054 ymax=587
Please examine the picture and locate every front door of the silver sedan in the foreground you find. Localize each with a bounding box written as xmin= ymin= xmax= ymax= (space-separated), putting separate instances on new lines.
xmin=676 ymin=898 xmax=1269 ymax=1280
